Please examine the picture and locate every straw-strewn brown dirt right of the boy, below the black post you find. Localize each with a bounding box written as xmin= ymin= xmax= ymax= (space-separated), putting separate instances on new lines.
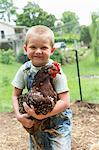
xmin=72 ymin=102 xmax=99 ymax=150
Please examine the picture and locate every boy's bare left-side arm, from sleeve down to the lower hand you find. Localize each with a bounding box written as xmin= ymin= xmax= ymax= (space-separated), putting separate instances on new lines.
xmin=12 ymin=87 xmax=34 ymax=128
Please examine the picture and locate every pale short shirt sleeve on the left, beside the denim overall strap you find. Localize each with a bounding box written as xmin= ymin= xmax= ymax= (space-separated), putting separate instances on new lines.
xmin=11 ymin=66 xmax=25 ymax=89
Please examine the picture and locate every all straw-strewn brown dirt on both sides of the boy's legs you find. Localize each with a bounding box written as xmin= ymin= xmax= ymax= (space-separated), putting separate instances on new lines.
xmin=0 ymin=102 xmax=99 ymax=150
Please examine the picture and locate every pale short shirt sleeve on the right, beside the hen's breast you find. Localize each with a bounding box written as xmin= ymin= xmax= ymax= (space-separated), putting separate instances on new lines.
xmin=53 ymin=67 xmax=69 ymax=94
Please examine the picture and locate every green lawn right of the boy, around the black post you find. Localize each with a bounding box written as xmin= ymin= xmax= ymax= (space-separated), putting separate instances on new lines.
xmin=63 ymin=50 xmax=99 ymax=103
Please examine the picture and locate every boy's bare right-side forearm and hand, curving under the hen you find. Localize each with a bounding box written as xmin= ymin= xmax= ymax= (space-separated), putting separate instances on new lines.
xmin=24 ymin=92 xmax=70 ymax=120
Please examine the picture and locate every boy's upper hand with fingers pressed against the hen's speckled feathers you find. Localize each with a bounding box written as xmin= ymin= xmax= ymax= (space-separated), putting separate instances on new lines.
xmin=23 ymin=102 xmax=47 ymax=120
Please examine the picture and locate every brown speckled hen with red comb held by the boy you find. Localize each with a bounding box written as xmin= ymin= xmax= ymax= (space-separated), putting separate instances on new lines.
xmin=18 ymin=62 xmax=60 ymax=134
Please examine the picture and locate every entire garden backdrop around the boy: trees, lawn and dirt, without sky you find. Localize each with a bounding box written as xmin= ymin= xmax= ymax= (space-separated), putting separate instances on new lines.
xmin=0 ymin=0 xmax=99 ymax=150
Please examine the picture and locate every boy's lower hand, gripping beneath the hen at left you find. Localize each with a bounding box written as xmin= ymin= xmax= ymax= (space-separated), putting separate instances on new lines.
xmin=17 ymin=114 xmax=35 ymax=128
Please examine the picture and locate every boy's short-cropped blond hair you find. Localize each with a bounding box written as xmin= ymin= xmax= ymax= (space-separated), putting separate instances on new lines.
xmin=24 ymin=25 xmax=54 ymax=47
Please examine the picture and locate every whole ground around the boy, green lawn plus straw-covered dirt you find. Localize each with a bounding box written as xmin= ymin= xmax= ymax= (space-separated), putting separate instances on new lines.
xmin=0 ymin=47 xmax=99 ymax=150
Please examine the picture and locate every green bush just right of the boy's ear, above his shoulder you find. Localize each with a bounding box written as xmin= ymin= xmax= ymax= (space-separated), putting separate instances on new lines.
xmin=51 ymin=48 xmax=65 ymax=65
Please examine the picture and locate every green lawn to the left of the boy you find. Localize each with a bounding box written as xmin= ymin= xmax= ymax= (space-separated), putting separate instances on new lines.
xmin=0 ymin=62 xmax=21 ymax=112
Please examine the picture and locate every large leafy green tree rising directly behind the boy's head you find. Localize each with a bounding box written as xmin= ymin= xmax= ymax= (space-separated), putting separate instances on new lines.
xmin=16 ymin=2 xmax=56 ymax=28
